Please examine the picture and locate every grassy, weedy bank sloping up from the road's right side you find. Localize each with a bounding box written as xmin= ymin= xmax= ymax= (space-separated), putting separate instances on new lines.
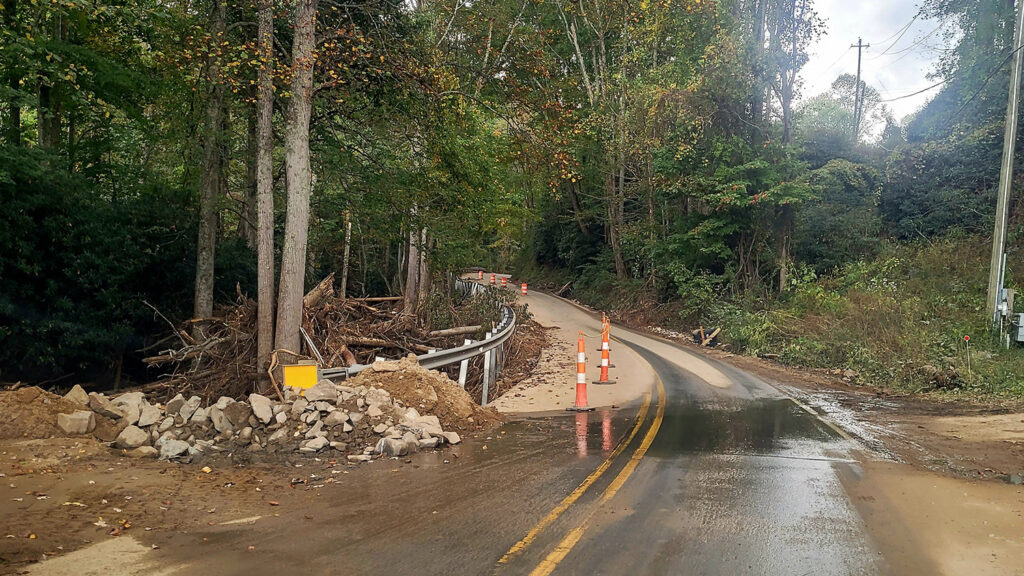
xmin=518 ymin=237 xmax=1024 ymax=400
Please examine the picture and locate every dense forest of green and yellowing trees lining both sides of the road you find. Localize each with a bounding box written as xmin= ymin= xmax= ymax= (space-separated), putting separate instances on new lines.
xmin=0 ymin=0 xmax=1024 ymax=394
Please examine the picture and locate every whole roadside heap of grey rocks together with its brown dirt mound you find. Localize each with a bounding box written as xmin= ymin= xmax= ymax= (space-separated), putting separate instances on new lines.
xmin=9 ymin=356 xmax=500 ymax=462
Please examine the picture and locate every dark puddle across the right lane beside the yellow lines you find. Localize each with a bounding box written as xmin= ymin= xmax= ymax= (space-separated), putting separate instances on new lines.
xmin=648 ymin=400 xmax=842 ymax=457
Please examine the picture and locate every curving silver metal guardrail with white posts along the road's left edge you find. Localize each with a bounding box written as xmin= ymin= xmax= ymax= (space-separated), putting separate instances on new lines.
xmin=319 ymin=279 xmax=516 ymax=406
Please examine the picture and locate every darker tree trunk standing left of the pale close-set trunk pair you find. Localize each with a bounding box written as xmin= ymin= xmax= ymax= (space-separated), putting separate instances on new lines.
xmin=193 ymin=0 xmax=226 ymax=337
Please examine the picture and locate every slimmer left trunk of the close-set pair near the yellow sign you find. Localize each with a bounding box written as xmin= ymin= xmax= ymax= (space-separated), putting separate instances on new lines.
xmin=256 ymin=0 xmax=273 ymax=374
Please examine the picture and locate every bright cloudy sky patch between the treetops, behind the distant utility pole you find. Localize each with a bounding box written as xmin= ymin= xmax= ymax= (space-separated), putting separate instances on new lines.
xmin=802 ymin=0 xmax=945 ymax=121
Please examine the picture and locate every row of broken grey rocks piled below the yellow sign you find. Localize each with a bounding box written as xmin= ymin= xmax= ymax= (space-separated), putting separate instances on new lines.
xmin=56 ymin=367 xmax=462 ymax=461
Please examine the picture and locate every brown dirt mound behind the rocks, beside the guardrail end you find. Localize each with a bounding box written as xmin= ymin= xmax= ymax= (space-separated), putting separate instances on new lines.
xmin=345 ymin=355 xmax=502 ymax=430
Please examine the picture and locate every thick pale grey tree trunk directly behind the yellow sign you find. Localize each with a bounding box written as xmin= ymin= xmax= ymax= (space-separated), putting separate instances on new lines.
xmin=275 ymin=0 xmax=316 ymax=351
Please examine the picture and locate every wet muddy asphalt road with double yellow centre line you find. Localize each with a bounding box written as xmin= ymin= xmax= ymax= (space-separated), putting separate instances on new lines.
xmin=149 ymin=294 xmax=887 ymax=576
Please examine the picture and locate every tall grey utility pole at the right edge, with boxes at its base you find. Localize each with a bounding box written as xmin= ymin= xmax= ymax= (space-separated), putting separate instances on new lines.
xmin=985 ymin=2 xmax=1024 ymax=332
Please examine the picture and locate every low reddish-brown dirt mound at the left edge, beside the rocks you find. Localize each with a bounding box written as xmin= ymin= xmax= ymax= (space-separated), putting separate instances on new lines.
xmin=0 ymin=386 xmax=83 ymax=440
